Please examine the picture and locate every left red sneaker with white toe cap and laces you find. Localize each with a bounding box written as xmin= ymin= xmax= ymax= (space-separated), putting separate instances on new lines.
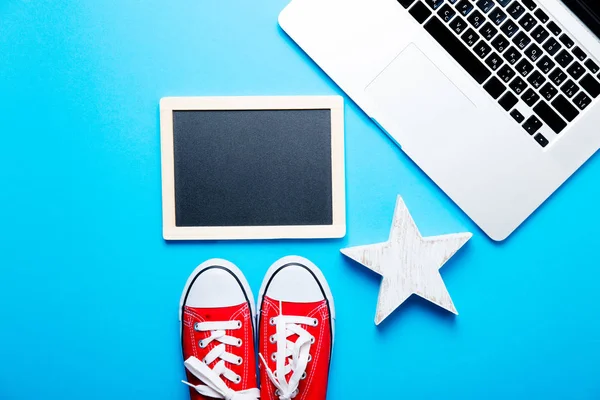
xmin=179 ymin=259 xmax=260 ymax=400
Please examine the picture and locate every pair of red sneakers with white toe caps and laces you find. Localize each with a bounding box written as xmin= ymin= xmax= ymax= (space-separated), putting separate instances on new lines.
xmin=180 ymin=257 xmax=335 ymax=400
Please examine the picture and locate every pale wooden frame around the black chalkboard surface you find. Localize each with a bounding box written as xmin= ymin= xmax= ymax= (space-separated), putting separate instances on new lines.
xmin=160 ymin=96 xmax=346 ymax=240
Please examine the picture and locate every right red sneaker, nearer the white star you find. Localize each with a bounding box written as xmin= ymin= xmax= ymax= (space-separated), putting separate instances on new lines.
xmin=258 ymin=256 xmax=335 ymax=400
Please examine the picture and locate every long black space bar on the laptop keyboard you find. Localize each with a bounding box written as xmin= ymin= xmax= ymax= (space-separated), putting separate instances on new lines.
xmin=424 ymin=17 xmax=491 ymax=84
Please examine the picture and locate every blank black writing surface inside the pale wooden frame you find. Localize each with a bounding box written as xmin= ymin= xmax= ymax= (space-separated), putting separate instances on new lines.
xmin=173 ymin=110 xmax=333 ymax=227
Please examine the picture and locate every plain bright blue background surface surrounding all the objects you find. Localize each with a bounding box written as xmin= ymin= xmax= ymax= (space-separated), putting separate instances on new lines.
xmin=0 ymin=0 xmax=600 ymax=400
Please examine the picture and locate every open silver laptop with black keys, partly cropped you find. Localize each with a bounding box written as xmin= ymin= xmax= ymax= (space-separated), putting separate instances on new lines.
xmin=279 ymin=0 xmax=600 ymax=241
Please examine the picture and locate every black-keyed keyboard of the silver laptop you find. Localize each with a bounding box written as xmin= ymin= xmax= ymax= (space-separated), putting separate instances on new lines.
xmin=398 ymin=0 xmax=600 ymax=147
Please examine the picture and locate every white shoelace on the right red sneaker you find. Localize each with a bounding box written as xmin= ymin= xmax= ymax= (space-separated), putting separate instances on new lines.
xmin=259 ymin=302 xmax=319 ymax=400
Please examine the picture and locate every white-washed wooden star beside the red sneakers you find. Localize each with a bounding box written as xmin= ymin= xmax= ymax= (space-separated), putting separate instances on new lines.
xmin=341 ymin=196 xmax=473 ymax=325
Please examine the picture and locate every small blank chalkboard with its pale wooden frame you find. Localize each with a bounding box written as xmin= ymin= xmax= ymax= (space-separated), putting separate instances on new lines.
xmin=161 ymin=96 xmax=345 ymax=239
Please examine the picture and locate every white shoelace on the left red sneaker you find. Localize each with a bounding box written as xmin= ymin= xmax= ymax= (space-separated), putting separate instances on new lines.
xmin=182 ymin=321 xmax=260 ymax=400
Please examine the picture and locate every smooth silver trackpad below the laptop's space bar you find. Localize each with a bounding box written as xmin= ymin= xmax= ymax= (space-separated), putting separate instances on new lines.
xmin=365 ymin=43 xmax=475 ymax=147
